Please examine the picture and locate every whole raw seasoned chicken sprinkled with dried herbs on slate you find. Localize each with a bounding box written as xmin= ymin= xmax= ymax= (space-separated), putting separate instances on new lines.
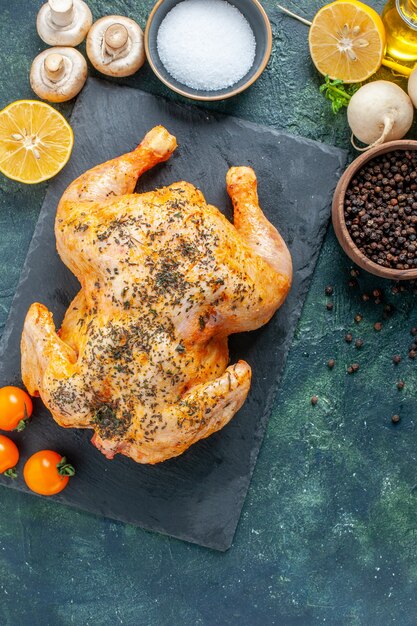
xmin=21 ymin=126 xmax=292 ymax=463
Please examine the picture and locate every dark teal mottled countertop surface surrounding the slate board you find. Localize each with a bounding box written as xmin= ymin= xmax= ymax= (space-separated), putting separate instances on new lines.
xmin=0 ymin=0 xmax=417 ymax=626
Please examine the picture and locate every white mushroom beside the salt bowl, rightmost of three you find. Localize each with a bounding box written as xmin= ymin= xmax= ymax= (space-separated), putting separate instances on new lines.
xmin=87 ymin=15 xmax=145 ymax=76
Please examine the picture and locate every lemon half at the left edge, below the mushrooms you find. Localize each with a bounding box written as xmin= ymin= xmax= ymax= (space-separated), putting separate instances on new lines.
xmin=0 ymin=100 xmax=74 ymax=184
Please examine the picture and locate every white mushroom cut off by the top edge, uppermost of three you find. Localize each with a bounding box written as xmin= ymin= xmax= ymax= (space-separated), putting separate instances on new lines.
xmin=36 ymin=0 xmax=93 ymax=46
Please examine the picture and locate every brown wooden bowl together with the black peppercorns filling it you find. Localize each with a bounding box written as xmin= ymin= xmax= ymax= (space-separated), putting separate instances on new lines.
xmin=332 ymin=139 xmax=417 ymax=280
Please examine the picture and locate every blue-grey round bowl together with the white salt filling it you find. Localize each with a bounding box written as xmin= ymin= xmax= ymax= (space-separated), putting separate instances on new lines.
xmin=145 ymin=0 xmax=272 ymax=101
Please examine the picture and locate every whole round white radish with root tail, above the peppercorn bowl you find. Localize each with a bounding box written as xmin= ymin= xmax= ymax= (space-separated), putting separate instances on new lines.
xmin=347 ymin=80 xmax=414 ymax=152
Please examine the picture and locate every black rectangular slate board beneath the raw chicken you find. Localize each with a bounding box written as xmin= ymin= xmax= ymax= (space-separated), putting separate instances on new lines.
xmin=0 ymin=79 xmax=345 ymax=550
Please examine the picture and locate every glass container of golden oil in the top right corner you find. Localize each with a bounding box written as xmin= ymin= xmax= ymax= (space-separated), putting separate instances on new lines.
xmin=382 ymin=0 xmax=417 ymax=62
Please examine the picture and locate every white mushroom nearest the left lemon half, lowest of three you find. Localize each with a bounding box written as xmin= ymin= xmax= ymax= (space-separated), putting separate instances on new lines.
xmin=30 ymin=48 xmax=87 ymax=102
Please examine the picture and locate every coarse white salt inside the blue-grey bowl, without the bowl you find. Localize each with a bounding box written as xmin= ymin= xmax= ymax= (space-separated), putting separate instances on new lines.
xmin=157 ymin=0 xmax=256 ymax=91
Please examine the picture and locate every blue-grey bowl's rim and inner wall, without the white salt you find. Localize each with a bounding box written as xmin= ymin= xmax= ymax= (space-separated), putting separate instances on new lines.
xmin=145 ymin=0 xmax=272 ymax=101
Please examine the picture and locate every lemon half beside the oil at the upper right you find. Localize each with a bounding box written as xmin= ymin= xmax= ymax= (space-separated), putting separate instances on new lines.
xmin=309 ymin=0 xmax=385 ymax=83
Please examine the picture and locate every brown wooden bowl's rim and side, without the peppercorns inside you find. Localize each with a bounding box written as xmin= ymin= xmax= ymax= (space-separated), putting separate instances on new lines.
xmin=332 ymin=139 xmax=417 ymax=280
